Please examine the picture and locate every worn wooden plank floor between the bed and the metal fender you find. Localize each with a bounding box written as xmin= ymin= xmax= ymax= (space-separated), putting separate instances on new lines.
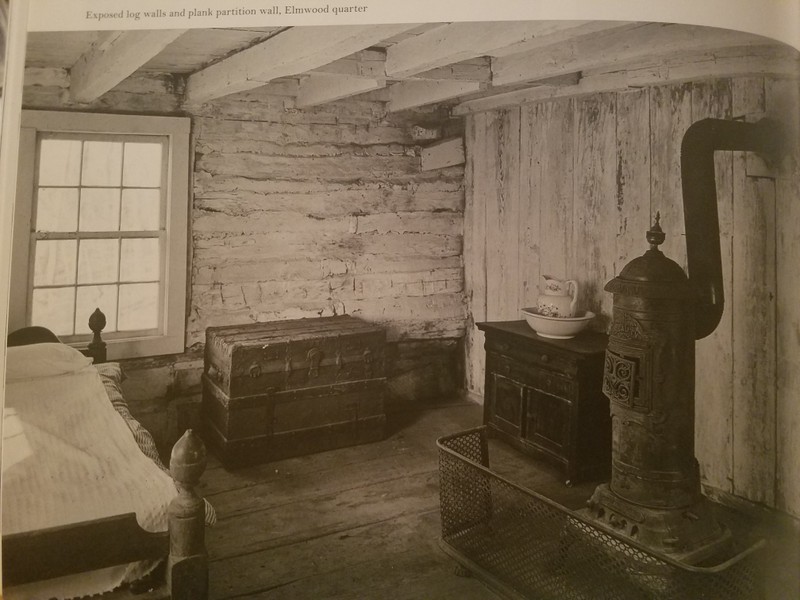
xmin=195 ymin=403 xmax=594 ymax=600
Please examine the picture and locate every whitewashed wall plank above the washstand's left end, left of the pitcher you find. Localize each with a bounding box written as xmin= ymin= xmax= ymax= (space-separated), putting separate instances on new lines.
xmin=486 ymin=108 xmax=520 ymax=320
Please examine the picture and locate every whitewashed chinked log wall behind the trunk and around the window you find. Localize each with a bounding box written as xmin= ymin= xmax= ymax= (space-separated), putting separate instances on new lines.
xmin=25 ymin=71 xmax=466 ymax=444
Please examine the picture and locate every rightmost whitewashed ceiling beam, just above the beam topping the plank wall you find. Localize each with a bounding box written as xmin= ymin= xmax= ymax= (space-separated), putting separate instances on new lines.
xmin=494 ymin=23 xmax=764 ymax=86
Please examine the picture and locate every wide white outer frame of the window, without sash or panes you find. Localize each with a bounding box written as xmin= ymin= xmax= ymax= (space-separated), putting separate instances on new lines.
xmin=9 ymin=110 xmax=191 ymax=360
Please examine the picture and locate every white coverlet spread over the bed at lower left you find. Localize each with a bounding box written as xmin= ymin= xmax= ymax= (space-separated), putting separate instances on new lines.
xmin=2 ymin=349 xmax=176 ymax=599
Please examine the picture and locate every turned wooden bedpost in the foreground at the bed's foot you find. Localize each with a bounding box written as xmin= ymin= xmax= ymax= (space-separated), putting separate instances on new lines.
xmin=167 ymin=429 xmax=208 ymax=600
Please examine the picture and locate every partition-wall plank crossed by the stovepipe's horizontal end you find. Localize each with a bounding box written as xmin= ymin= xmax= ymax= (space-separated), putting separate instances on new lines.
xmin=731 ymin=77 xmax=776 ymax=505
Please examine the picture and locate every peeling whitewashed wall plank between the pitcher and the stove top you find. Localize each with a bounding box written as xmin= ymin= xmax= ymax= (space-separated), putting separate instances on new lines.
xmin=570 ymin=93 xmax=617 ymax=315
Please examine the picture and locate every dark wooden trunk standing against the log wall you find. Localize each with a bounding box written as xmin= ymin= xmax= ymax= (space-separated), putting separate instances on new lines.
xmin=203 ymin=315 xmax=386 ymax=467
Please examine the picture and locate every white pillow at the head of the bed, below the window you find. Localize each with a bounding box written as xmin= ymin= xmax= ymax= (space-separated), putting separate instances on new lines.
xmin=6 ymin=343 xmax=92 ymax=381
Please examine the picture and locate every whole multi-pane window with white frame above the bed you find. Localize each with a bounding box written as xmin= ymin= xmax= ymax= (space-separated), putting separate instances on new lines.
xmin=10 ymin=111 xmax=189 ymax=358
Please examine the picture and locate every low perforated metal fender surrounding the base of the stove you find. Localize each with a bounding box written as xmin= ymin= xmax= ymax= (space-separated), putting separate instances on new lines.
xmin=437 ymin=427 xmax=765 ymax=600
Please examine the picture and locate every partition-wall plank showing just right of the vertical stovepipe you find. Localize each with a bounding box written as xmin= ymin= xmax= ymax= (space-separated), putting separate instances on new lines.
xmin=692 ymin=79 xmax=734 ymax=492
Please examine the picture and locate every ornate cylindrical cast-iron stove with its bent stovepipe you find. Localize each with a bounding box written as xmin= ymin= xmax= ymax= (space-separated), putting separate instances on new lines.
xmin=588 ymin=119 xmax=775 ymax=564
